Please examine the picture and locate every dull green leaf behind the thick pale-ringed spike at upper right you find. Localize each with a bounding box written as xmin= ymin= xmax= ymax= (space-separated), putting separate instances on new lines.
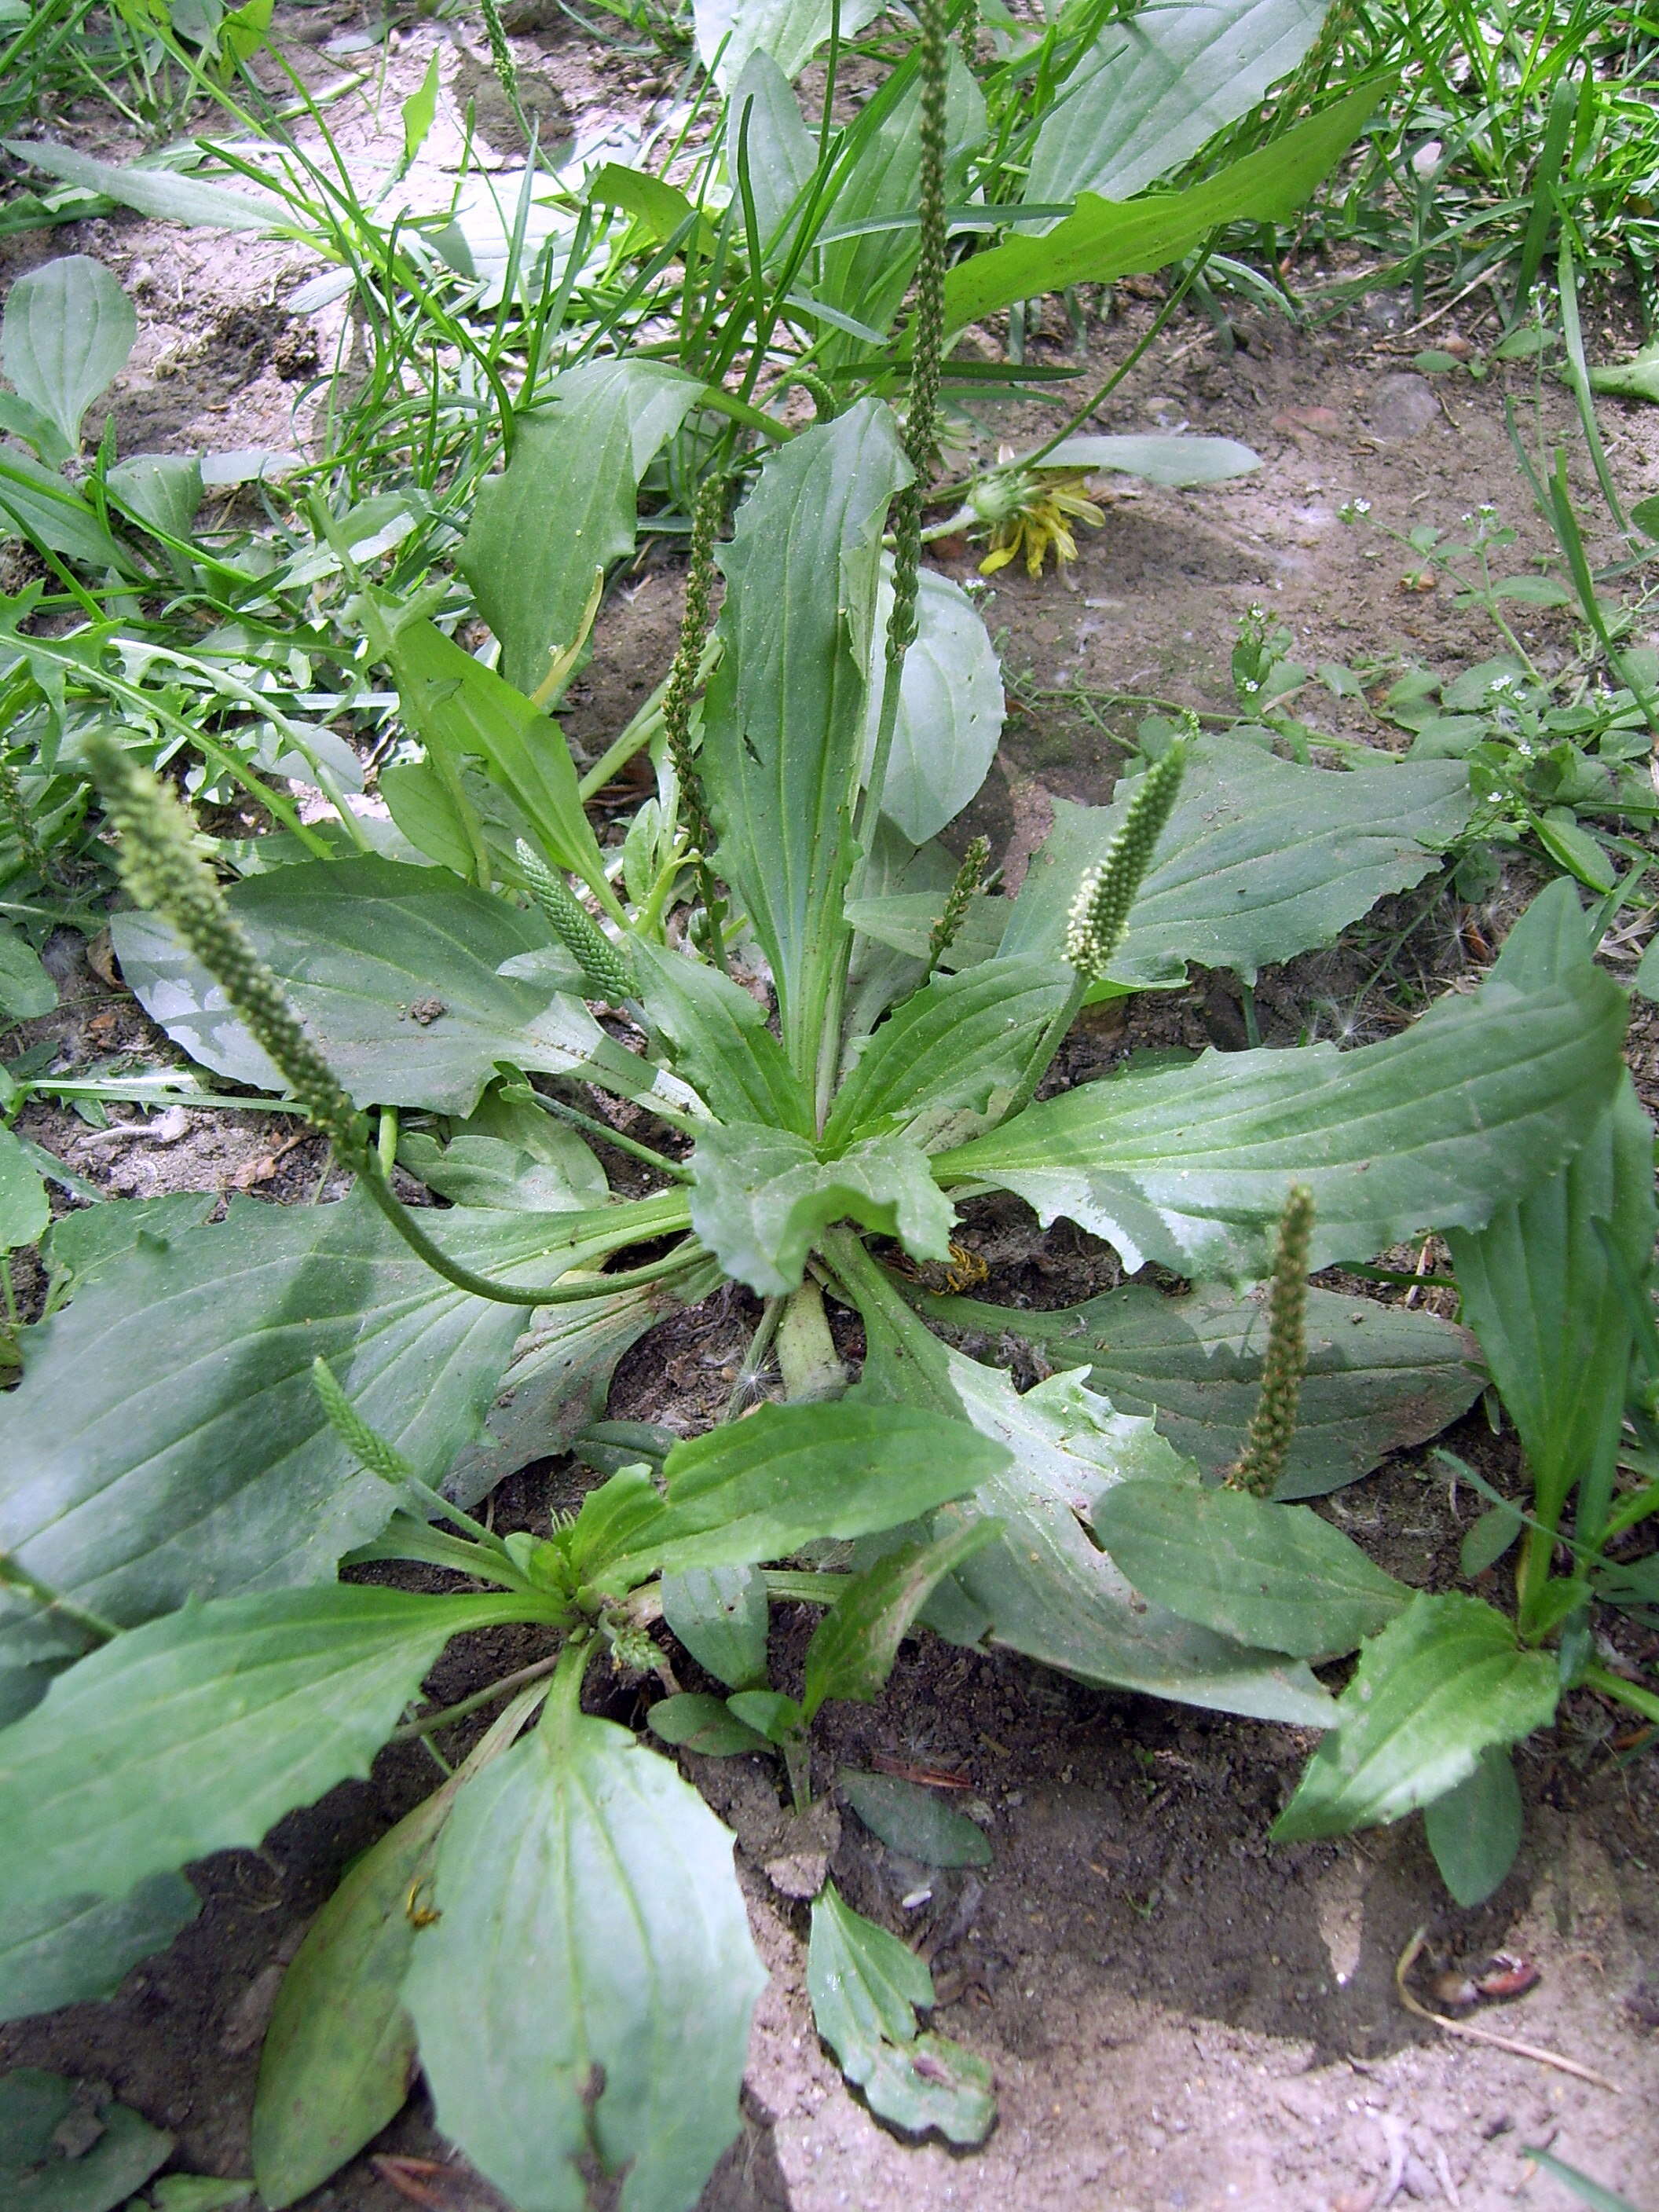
xmin=1002 ymin=737 xmax=1473 ymax=989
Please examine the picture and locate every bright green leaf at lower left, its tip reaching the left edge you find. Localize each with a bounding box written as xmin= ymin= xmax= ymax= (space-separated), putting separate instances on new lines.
xmin=0 ymin=1584 xmax=524 ymax=1909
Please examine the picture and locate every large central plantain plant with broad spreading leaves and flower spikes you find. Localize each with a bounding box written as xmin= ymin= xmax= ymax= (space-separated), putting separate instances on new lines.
xmin=0 ymin=5 xmax=1628 ymax=2212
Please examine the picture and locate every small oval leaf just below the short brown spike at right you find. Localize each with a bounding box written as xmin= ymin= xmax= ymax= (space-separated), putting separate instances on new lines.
xmin=1090 ymin=1482 xmax=1412 ymax=1659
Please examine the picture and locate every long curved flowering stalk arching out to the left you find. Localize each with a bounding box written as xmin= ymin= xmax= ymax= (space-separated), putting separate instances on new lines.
xmin=86 ymin=737 xmax=661 ymax=1305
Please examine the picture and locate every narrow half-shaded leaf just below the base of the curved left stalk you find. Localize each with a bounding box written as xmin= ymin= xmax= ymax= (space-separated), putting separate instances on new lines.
xmin=445 ymin=1263 xmax=719 ymax=1507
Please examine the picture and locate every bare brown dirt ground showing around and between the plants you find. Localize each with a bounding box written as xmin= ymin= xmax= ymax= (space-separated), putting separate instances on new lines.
xmin=0 ymin=9 xmax=1659 ymax=2212
